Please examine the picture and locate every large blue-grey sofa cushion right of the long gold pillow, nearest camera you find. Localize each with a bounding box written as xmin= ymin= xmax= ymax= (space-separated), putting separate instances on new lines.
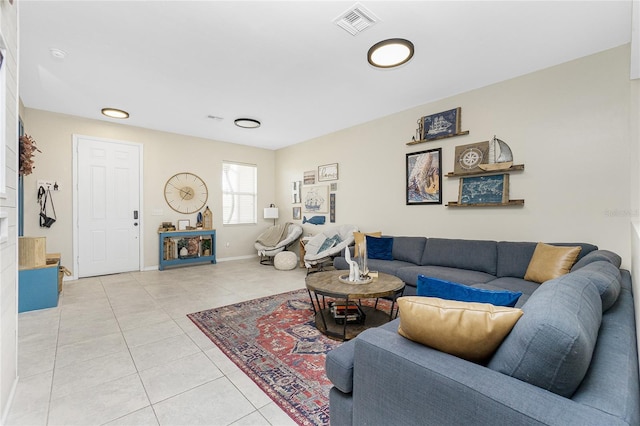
xmin=488 ymin=274 xmax=602 ymax=398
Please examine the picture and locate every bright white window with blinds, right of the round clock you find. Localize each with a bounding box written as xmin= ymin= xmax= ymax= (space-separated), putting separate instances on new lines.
xmin=222 ymin=162 xmax=258 ymax=225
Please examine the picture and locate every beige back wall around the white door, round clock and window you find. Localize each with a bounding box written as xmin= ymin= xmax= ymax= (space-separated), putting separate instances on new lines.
xmin=23 ymin=108 xmax=275 ymax=269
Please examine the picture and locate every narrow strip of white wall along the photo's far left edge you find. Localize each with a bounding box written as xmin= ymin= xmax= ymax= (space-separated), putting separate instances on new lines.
xmin=0 ymin=1 xmax=18 ymax=424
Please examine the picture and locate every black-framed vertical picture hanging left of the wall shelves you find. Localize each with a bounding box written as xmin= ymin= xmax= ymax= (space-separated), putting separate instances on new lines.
xmin=406 ymin=148 xmax=442 ymax=205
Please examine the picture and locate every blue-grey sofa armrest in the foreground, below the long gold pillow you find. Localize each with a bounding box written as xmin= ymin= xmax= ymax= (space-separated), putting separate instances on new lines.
xmin=353 ymin=328 xmax=625 ymax=425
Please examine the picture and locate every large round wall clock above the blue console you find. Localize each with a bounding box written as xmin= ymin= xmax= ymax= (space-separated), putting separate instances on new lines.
xmin=164 ymin=172 xmax=209 ymax=214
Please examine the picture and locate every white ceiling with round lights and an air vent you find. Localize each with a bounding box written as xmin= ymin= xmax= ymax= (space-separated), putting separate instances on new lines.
xmin=14 ymin=0 xmax=631 ymax=149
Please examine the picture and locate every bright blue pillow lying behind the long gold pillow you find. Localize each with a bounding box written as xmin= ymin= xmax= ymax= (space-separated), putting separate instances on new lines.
xmin=416 ymin=275 xmax=522 ymax=308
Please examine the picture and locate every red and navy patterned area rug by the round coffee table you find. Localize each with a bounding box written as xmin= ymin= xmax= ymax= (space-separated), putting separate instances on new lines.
xmin=187 ymin=290 xmax=340 ymax=425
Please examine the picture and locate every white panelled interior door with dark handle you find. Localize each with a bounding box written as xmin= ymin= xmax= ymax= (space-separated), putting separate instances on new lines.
xmin=74 ymin=136 xmax=142 ymax=278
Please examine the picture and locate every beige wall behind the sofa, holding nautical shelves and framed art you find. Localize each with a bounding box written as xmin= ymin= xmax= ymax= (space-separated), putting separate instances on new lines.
xmin=276 ymin=46 xmax=638 ymax=267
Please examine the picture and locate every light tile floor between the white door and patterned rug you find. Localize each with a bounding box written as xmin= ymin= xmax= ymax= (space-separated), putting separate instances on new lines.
xmin=7 ymin=259 xmax=306 ymax=426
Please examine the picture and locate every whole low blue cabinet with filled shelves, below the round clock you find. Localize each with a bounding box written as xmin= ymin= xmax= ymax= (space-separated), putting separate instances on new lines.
xmin=158 ymin=229 xmax=216 ymax=271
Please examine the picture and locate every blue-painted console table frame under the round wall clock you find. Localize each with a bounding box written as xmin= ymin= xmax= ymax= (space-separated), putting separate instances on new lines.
xmin=158 ymin=229 xmax=216 ymax=271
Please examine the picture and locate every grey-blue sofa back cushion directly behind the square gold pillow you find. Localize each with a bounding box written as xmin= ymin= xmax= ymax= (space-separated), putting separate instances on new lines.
xmin=496 ymin=241 xmax=598 ymax=278
